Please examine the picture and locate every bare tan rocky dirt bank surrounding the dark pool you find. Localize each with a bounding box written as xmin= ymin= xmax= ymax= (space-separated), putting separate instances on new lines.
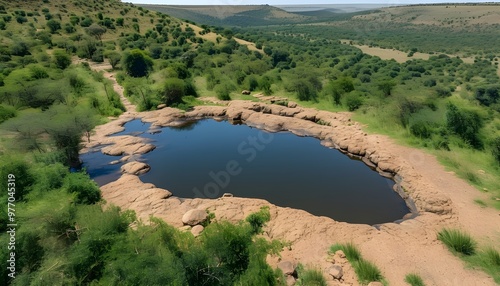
xmin=84 ymin=101 xmax=500 ymax=285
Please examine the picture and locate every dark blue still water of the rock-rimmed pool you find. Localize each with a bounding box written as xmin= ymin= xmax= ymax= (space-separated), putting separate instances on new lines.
xmin=83 ymin=120 xmax=409 ymax=224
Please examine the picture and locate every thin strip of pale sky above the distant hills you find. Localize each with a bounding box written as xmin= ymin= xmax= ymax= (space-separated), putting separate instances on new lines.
xmin=126 ymin=0 xmax=498 ymax=6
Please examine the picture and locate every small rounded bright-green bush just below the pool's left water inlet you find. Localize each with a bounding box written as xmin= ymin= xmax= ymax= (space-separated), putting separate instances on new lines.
xmin=64 ymin=172 xmax=101 ymax=204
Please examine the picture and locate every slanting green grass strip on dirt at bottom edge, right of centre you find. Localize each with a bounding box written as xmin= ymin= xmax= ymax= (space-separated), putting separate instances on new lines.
xmin=330 ymin=243 xmax=386 ymax=284
